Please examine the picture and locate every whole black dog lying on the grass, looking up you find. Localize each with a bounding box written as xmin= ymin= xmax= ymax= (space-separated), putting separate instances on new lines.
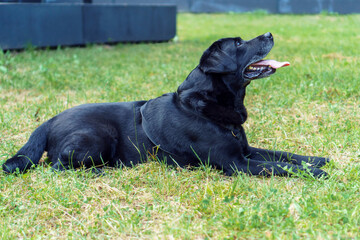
xmin=3 ymin=33 xmax=329 ymax=177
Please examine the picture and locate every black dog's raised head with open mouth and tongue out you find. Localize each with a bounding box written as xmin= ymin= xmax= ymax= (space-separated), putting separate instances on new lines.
xmin=199 ymin=32 xmax=289 ymax=84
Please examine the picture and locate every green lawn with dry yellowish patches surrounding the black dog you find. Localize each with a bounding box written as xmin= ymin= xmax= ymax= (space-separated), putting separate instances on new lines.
xmin=0 ymin=13 xmax=360 ymax=239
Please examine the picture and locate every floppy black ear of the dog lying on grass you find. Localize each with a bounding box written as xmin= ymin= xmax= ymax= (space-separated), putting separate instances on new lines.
xmin=199 ymin=41 xmax=237 ymax=73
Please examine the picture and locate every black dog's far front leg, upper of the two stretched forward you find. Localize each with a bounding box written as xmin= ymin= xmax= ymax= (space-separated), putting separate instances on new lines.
xmin=248 ymin=147 xmax=330 ymax=168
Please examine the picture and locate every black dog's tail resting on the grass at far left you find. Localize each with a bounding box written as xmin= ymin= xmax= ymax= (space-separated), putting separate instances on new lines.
xmin=2 ymin=121 xmax=50 ymax=173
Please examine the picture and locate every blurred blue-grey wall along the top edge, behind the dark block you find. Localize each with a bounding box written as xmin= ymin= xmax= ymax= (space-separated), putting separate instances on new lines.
xmin=0 ymin=0 xmax=360 ymax=14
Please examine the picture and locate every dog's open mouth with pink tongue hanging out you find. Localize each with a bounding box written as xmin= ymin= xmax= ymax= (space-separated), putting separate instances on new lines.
xmin=244 ymin=60 xmax=290 ymax=80
